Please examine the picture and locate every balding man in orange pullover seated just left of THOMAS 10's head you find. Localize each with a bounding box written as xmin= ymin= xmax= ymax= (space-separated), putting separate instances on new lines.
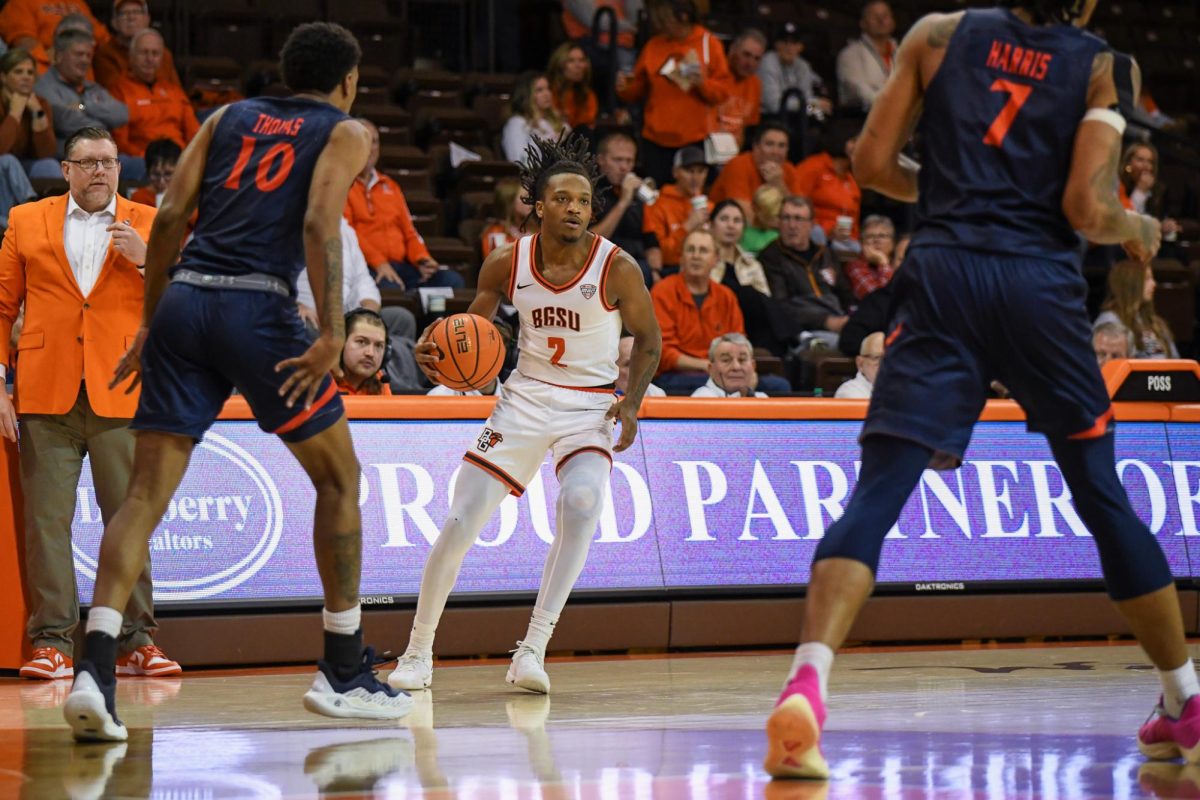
xmin=113 ymin=28 xmax=200 ymax=157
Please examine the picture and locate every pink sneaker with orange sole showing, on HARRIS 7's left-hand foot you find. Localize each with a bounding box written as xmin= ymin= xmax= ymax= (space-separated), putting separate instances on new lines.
xmin=762 ymin=664 xmax=829 ymax=781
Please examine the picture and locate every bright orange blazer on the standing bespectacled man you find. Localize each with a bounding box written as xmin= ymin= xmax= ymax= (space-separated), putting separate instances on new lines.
xmin=0 ymin=194 xmax=157 ymax=419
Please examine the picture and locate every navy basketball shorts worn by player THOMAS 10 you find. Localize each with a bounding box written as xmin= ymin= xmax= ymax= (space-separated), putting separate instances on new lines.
xmin=132 ymin=283 xmax=343 ymax=441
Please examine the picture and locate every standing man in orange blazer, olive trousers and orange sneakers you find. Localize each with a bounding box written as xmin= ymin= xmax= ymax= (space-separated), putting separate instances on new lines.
xmin=0 ymin=128 xmax=178 ymax=679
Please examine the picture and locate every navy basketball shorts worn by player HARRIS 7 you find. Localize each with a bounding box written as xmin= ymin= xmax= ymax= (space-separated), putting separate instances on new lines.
xmin=863 ymin=247 xmax=1112 ymax=461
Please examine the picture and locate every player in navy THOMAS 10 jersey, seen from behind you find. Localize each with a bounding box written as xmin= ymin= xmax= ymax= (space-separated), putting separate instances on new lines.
xmin=64 ymin=23 xmax=412 ymax=741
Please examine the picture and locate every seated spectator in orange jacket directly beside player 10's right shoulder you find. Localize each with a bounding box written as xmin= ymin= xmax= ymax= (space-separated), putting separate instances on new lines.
xmin=346 ymin=118 xmax=463 ymax=291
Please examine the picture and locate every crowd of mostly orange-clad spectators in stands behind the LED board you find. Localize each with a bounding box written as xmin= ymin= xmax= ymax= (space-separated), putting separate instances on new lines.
xmin=0 ymin=0 xmax=1200 ymax=396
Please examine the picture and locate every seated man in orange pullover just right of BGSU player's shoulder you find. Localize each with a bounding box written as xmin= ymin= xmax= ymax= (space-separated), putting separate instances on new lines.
xmin=650 ymin=229 xmax=745 ymax=393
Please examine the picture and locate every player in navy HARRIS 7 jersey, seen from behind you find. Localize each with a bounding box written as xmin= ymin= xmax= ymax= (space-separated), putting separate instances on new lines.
xmin=764 ymin=0 xmax=1200 ymax=778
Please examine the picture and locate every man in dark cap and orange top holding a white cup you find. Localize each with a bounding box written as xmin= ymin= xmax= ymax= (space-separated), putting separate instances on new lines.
xmin=642 ymin=148 xmax=713 ymax=283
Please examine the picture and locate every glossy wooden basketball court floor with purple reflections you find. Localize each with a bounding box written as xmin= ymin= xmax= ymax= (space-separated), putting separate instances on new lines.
xmin=0 ymin=643 xmax=1185 ymax=800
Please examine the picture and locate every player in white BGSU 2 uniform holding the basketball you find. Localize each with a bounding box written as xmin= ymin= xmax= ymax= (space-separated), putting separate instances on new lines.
xmin=389 ymin=134 xmax=662 ymax=693
